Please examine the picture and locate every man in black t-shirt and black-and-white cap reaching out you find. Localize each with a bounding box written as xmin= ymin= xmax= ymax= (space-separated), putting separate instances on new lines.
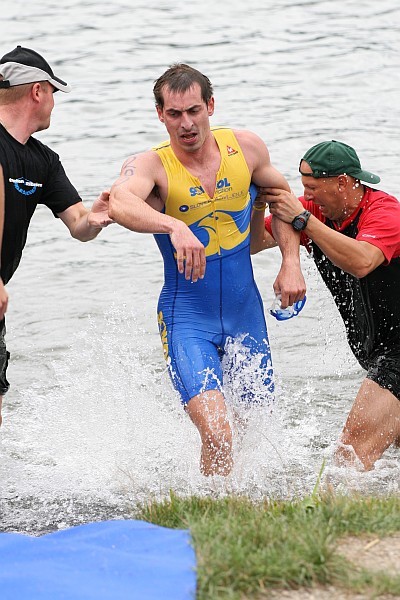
xmin=0 ymin=46 xmax=111 ymax=424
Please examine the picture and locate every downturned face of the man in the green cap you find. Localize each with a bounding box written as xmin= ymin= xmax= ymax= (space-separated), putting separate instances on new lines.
xmin=300 ymin=160 xmax=346 ymax=221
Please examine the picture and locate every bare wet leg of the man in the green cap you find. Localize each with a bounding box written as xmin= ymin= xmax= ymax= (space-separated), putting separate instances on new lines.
xmin=336 ymin=379 xmax=400 ymax=471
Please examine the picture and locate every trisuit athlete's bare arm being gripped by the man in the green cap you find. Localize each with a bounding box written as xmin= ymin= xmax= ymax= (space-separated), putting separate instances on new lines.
xmin=235 ymin=131 xmax=306 ymax=308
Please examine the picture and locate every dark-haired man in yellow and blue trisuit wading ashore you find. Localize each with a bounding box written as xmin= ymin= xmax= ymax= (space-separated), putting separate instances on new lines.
xmin=110 ymin=64 xmax=305 ymax=475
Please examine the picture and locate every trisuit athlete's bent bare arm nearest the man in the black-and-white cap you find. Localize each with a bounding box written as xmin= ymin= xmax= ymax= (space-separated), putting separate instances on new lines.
xmin=109 ymin=151 xmax=206 ymax=281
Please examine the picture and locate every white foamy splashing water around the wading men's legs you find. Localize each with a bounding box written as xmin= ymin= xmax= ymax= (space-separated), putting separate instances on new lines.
xmin=1 ymin=306 xmax=400 ymax=531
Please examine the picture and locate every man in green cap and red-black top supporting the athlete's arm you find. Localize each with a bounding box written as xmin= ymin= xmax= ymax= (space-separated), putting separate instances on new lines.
xmin=252 ymin=141 xmax=400 ymax=469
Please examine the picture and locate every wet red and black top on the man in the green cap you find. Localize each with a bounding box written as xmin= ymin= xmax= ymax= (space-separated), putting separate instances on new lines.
xmin=266 ymin=186 xmax=400 ymax=399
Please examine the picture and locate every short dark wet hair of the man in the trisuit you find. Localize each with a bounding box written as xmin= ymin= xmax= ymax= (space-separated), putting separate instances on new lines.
xmin=153 ymin=63 xmax=213 ymax=108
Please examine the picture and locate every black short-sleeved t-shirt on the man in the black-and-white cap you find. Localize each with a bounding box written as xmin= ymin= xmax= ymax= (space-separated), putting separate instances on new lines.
xmin=0 ymin=125 xmax=81 ymax=283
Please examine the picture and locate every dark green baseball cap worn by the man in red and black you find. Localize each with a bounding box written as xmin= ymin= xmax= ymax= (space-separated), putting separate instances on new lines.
xmin=299 ymin=140 xmax=381 ymax=183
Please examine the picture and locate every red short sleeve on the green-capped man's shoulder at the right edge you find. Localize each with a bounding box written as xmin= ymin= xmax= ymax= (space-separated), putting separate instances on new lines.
xmin=356 ymin=189 xmax=400 ymax=263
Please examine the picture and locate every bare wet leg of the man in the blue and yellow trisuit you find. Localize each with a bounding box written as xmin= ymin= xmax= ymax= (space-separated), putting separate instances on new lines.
xmin=186 ymin=390 xmax=233 ymax=476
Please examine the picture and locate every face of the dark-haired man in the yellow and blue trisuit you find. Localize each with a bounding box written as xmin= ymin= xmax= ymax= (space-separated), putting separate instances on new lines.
xmin=157 ymin=83 xmax=214 ymax=152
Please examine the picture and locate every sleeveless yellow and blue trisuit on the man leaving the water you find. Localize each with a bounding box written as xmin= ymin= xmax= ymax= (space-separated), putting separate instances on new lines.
xmin=154 ymin=128 xmax=273 ymax=404
